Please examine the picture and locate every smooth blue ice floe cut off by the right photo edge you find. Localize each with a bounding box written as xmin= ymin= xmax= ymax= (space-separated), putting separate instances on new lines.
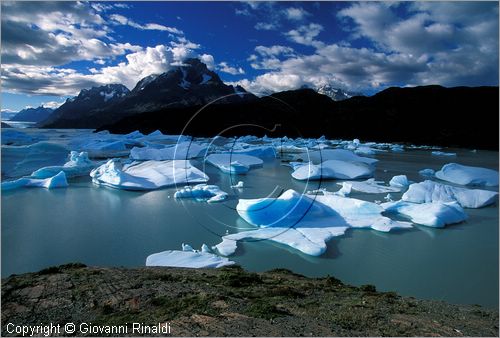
xmin=436 ymin=163 xmax=498 ymax=187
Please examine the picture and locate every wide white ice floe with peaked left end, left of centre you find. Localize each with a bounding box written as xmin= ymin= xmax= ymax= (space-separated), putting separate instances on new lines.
xmin=90 ymin=159 xmax=209 ymax=190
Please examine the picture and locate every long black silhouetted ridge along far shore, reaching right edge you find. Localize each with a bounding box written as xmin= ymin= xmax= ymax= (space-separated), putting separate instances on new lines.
xmin=100 ymin=86 xmax=499 ymax=150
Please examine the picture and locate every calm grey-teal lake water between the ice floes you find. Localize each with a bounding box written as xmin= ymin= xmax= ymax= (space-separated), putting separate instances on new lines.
xmin=1 ymin=129 xmax=499 ymax=308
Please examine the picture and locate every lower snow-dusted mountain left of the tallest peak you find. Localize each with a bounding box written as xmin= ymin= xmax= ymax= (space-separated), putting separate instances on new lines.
xmin=40 ymin=84 xmax=130 ymax=128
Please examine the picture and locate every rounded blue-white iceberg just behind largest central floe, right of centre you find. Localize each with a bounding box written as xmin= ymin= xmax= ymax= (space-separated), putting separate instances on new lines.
xmin=292 ymin=160 xmax=375 ymax=181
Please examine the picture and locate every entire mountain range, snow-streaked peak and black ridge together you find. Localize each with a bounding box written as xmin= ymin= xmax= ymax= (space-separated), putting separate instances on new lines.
xmin=40 ymin=59 xmax=499 ymax=149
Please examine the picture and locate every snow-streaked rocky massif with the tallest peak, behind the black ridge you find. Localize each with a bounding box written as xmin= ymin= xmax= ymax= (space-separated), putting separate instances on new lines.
xmin=42 ymin=59 xmax=256 ymax=128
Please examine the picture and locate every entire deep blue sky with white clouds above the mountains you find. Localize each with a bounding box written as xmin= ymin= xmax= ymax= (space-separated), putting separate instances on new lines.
xmin=1 ymin=2 xmax=498 ymax=110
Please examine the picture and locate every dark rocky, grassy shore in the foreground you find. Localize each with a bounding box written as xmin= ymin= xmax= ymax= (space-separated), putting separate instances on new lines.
xmin=2 ymin=264 xmax=499 ymax=336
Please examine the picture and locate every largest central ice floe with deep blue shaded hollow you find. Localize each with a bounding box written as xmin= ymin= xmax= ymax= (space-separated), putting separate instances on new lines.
xmin=215 ymin=189 xmax=411 ymax=256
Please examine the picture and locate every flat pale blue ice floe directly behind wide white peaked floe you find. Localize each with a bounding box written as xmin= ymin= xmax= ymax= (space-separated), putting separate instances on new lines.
xmin=130 ymin=142 xmax=207 ymax=161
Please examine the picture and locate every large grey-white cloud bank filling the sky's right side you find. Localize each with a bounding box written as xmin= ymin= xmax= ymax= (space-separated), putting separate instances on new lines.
xmin=235 ymin=2 xmax=498 ymax=95
